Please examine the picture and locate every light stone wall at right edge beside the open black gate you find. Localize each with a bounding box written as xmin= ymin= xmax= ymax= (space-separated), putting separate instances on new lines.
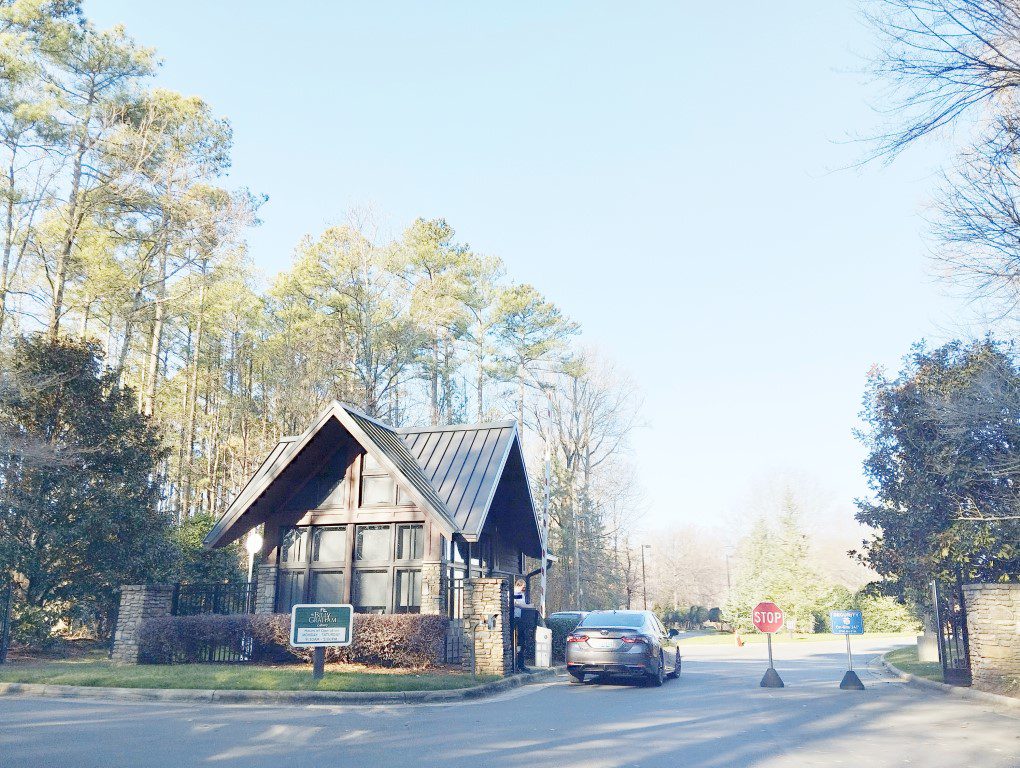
xmin=963 ymin=583 xmax=1020 ymax=687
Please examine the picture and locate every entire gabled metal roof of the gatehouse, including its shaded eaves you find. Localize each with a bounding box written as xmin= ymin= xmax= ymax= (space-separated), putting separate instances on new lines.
xmin=204 ymin=403 xmax=543 ymax=553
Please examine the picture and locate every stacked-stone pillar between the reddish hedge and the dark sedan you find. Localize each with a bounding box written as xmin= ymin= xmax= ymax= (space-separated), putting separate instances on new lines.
xmin=460 ymin=577 xmax=513 ymax=676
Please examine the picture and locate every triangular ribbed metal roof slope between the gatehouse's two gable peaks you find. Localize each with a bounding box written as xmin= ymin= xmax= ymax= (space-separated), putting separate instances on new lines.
xmin=397 ymin=421 xmax=517 ymax=535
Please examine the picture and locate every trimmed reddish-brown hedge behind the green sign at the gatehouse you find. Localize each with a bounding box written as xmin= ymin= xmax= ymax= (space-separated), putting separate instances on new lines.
xmin=139 ymin=613 xmax=450 ymax=669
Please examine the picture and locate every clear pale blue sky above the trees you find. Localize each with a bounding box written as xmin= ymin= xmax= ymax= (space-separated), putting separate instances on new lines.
xmin=86 ymin=0 xmax=961 ymax=527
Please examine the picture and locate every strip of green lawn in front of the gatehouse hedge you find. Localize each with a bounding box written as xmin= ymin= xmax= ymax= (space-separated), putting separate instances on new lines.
xmin=0 ymin=660 xmax=496 ymax=692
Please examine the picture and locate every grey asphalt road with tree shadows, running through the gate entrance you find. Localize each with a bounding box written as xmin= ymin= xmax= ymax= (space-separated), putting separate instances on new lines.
xmin=0 ymin=641 xmax=1020 ymax=768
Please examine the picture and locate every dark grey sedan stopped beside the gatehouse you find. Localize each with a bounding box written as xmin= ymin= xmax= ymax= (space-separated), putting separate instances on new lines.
xmin=567 ymin=611 xmax=680 ymax=685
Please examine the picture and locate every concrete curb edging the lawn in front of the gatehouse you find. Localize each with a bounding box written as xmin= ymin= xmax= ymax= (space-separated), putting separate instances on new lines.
xmin=0 ymin=666 xmax=566 ymax=705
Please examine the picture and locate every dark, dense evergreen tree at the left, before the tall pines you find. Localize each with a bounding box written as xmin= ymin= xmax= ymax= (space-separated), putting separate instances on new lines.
xmin=0 ymin=336 xmax=173 ymax=634
